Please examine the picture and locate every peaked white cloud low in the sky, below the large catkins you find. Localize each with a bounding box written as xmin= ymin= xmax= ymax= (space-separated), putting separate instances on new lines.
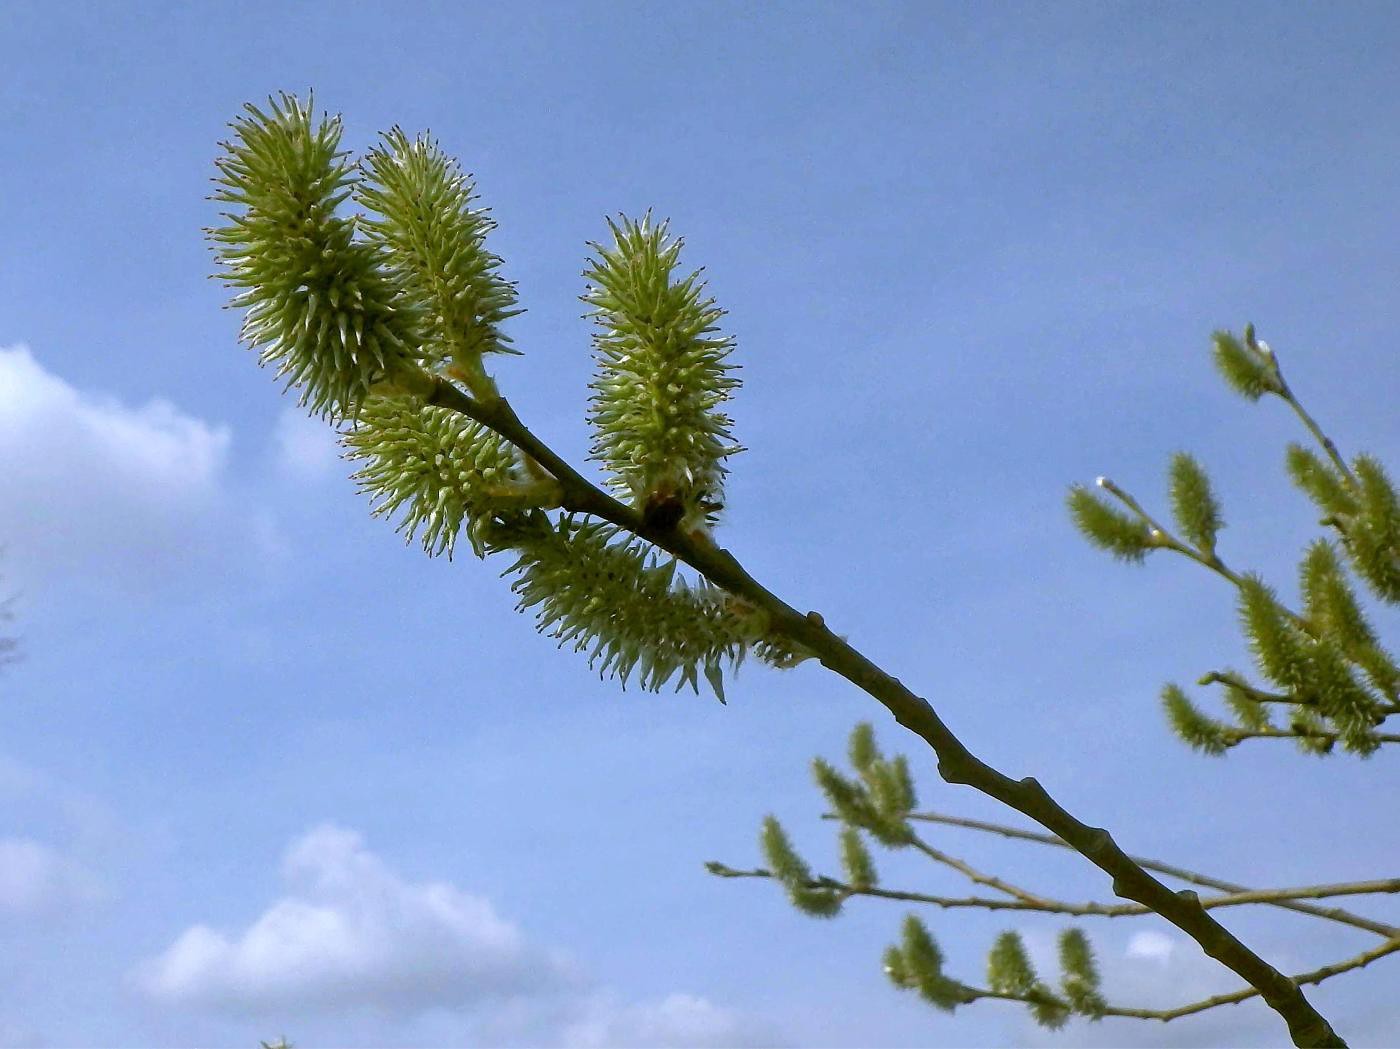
xmin=137 ymin=825 xmax=568 ymax=1014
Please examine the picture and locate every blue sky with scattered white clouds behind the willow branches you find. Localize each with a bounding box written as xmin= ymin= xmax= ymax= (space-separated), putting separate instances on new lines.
xmin=0 ymin=3 xmax=1400 ymax=1046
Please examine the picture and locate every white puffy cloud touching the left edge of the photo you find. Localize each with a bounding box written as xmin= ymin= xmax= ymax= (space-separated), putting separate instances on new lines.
xmin=0 ymin=346 xmax=249 ymax=583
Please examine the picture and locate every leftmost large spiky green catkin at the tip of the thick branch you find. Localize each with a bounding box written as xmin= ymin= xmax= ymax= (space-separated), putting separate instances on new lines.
xmin=209 ymin=94 xmax=423 ymax=419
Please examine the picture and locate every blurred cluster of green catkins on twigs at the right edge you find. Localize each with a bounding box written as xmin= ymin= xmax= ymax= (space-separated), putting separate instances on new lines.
xmin=1068 ymin=326 xmax=1400 ymax=756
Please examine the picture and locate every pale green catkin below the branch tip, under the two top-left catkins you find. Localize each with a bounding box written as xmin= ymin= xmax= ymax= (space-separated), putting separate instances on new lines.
xmin=340 ymin=396 xmax=524 ymax=557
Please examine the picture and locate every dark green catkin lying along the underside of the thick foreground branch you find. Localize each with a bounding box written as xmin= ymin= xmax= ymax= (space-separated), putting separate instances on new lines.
xmin=505 ymin=514 xmax=785 ymax=702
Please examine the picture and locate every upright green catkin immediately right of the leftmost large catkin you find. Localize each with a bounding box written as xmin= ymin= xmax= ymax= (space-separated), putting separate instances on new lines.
xmin=356 ymin=127 xmax=522 ymax=383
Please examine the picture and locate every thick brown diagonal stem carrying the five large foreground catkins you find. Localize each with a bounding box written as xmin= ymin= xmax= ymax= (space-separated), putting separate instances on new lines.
xmin=426 ymin=378 xmax=1345 ymax=1046
